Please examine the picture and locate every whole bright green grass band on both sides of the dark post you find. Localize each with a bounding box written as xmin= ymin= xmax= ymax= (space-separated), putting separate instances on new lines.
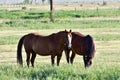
xmin=0 ymin=9 xmax=120 ymax=19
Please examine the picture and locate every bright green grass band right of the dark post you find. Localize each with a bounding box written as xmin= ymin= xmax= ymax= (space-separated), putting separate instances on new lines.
xmin=55 ymin=9 xmax=120 ymax=18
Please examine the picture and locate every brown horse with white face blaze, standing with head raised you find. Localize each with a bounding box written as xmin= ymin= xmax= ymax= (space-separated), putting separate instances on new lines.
xmin=17 ymin=30 xmax=71 ymax=67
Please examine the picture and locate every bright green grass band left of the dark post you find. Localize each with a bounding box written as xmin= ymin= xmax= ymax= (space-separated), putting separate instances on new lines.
xmin=0 ymin=10 xmax=49 ymax=19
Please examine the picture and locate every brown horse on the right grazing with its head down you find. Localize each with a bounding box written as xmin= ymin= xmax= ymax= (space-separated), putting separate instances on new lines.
xmin=65 ymin=32 xmax=95 ymax=67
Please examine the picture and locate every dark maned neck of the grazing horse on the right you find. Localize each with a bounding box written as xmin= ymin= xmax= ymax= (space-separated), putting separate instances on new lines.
xmin=87 ymin=35 xmax=95 ymax=57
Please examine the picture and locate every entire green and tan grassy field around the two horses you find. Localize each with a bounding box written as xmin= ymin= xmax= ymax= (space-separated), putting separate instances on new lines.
xmin=0 ymin=3 xmax=120 ymax=80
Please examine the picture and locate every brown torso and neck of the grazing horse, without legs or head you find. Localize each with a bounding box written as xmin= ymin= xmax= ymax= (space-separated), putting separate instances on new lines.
xmin=72 ymin=32 xmax=95 ymax=55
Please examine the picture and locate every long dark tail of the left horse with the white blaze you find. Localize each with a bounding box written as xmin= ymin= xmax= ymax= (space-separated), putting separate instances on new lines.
xmin=17 ymin=36 xmax=25 ymax=66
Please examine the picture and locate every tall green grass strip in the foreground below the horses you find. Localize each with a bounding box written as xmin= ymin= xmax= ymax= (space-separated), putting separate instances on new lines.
xmin=0 ymin=64 xmax=120 ymax=80
